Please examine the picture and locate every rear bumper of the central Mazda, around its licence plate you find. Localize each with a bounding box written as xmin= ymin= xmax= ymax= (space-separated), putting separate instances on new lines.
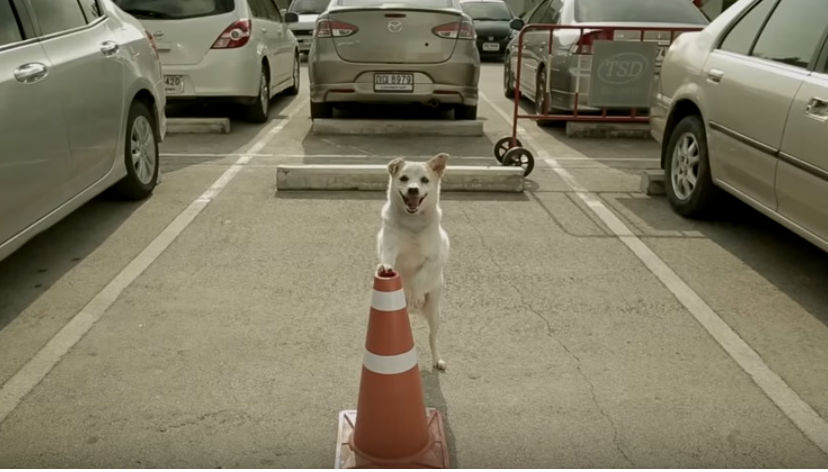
xmin=308 ymin=51 xmax=480 ymax=105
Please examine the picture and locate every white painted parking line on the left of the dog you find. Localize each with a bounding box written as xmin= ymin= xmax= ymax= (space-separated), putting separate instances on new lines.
xmin=0 ymin=100 xmax=305 ymax=423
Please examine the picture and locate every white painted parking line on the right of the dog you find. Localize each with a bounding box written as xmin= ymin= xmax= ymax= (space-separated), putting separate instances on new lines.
xmin=480 ymin=93 xmax=828 ymax=453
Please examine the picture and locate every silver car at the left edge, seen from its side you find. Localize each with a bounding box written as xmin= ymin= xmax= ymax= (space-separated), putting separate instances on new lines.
xmin=0 ymin=0 xmax=166 ymax=259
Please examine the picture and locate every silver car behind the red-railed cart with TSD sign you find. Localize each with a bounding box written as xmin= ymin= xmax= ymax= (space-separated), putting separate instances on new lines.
xmin=503 ymin=0 xmax=708 ymax=114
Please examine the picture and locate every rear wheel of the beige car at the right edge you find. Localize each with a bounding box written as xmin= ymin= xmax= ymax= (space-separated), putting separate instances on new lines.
xmin=664 ymin=116 xmax=719 ymax=217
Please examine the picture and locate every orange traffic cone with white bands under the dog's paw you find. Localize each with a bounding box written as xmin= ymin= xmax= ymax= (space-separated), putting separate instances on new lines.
xmin=336 ymin=272 xmax=449 ymax=468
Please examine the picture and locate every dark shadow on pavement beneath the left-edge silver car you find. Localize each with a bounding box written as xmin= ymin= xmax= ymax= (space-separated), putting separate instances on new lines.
xmin=0 ymin=192 xmax=145 ymax=329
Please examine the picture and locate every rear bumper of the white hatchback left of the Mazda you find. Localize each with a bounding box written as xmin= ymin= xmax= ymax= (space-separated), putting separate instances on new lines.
xmin=163 ymin=47 xmax=261 ymax=101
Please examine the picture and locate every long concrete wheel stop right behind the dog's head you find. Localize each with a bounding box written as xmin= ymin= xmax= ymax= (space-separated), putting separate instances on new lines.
xmin=276 ymin=165 xmax=524 ymax=192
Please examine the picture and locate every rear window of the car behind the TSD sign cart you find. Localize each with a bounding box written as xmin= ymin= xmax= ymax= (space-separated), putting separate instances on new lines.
xmin=575 ymin=0 xmax=708 ymax=25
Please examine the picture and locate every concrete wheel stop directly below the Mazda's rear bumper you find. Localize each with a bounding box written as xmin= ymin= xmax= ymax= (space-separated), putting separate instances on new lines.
xmin=311 ymin=119 xmax=483 ymax=136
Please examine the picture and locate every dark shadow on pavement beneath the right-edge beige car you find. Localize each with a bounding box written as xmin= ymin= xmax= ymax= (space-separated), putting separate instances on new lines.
xmin=618 ymin=195 xmax=828 ymax=326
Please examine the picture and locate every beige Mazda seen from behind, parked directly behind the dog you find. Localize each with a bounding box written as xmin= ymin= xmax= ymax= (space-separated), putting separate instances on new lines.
xmin=308 ymin=0 xmax=480 ymax=120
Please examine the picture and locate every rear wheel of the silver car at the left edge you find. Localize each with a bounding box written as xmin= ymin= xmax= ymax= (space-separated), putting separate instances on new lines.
xmin=115 ymin=102 xmax=158 ymax=200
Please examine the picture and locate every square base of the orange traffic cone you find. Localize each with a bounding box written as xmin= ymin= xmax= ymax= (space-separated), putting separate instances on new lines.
xmin=334 ymin=408 xmax=449 ymax=469
